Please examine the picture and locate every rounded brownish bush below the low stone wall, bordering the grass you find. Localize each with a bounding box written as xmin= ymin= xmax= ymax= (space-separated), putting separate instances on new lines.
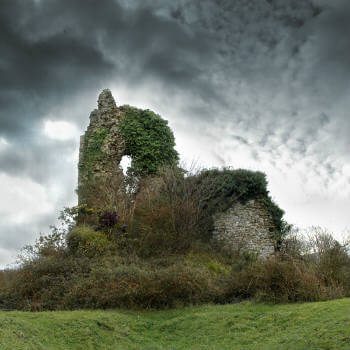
xmin=228 ymin=256 xmax=346 ymax=303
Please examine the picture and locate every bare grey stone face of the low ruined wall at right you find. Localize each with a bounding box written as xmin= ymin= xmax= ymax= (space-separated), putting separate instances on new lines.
xmin=213 ymin=199 xmax=276 ymax=258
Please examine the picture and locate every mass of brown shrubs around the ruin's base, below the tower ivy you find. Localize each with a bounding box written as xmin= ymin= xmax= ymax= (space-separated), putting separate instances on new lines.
xmin=0 ymin=167 xmax=350 ymax=311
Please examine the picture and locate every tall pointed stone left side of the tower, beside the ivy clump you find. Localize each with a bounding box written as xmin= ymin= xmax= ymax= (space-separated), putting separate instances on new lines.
xmin=78 ymin=89 xmax=125 ymax=208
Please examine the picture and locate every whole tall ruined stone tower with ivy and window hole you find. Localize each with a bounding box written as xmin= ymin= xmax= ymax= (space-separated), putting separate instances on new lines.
xmin=78 ymin=89 xmax=178 ymax=210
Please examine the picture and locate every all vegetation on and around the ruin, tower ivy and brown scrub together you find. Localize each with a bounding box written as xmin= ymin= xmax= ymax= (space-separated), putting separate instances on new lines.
xmin=0 ymin=106 xmax=350 ymax=311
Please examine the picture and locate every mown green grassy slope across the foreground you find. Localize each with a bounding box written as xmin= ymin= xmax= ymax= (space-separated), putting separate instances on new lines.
xmin=0 ymin=299 xmax=350 ymax=350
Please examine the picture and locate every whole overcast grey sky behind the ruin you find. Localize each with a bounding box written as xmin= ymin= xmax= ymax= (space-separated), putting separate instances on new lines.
xmin=0 ymin=0 xmax=350 ymax=266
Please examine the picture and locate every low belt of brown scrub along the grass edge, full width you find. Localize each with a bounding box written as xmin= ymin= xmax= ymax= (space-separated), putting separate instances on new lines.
xmin=0 ymin=241 xmax=350 ymax=310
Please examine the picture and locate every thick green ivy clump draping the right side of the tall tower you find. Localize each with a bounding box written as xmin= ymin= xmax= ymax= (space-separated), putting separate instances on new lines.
xmin=119 ymin=105 xmax=179 ymax=176
